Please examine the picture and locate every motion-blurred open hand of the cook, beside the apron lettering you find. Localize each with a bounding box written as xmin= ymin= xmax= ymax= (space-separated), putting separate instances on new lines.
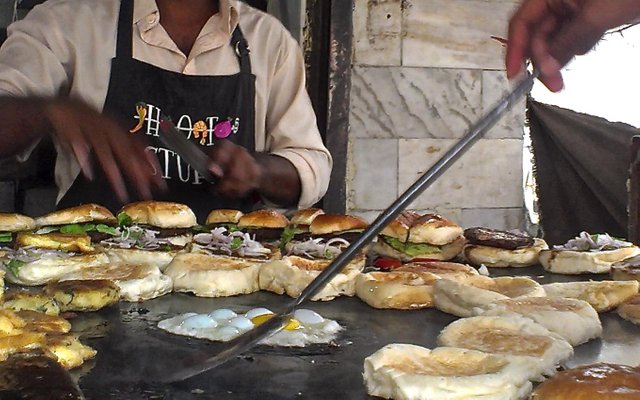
xmin=43 ymin=100 xmax=166 ymax=202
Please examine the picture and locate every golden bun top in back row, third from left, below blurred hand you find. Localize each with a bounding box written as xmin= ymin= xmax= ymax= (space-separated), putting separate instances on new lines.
xmin=120 ymin=200 xmax=198 ymax=229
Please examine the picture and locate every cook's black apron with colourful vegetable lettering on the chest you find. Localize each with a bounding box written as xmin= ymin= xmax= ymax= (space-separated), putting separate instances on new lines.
xmin=57 ymin=0 xmax=255 ymax=220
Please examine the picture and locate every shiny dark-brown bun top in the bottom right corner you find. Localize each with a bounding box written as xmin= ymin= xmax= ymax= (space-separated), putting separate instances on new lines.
xmin=531 ymin=363 xmax=640 ymax=400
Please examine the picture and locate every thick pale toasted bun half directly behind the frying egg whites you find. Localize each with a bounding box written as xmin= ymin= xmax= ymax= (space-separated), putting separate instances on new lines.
xmin=165 ymin=253 xmax=262 ymax=297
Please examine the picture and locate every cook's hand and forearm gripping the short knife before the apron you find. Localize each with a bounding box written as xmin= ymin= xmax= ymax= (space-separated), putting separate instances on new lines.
xmin=209 ymin=140 xmax=300 ymax=206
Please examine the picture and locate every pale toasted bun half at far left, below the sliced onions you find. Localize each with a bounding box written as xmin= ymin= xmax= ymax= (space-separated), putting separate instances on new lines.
xmin=6 ymin=253 xmax=109 ymax=286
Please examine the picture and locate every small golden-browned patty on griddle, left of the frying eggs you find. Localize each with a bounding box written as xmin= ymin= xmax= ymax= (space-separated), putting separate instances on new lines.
xmin=44 ymin=279 xmax=120 ymax=311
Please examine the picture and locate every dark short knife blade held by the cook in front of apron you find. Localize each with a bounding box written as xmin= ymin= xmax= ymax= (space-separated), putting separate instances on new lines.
xmin=160 ymin=117 xmax=216 ymax=183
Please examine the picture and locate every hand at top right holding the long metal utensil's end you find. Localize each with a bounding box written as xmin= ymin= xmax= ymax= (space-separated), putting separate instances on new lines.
xmin=506 ymin=0 xmax=640 ymax=92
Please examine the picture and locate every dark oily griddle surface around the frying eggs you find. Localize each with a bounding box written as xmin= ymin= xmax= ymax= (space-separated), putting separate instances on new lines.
xmin=62 ymin=267 xmax=640 ymax=400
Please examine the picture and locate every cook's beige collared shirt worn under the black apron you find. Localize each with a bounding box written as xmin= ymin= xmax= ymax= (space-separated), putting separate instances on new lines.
xmin=0 ymin=0 xmax=332 ymax=207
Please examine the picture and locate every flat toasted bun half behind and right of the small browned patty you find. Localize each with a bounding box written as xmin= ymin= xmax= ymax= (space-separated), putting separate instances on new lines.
xmin=60 ymin=263 xmax=173 ymax=302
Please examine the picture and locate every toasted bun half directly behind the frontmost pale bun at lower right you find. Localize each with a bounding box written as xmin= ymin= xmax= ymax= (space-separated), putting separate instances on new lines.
xmin=438 ymin=315 xmax=573 ymax=381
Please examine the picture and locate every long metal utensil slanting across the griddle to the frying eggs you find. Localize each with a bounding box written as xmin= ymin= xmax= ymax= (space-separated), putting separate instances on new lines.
xmin=163 ymin=72 xmax=538 ymax=383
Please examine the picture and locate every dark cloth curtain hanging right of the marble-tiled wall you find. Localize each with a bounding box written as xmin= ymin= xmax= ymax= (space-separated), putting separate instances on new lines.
xmin=527 ymin=99 xmax=640 ymax=244
